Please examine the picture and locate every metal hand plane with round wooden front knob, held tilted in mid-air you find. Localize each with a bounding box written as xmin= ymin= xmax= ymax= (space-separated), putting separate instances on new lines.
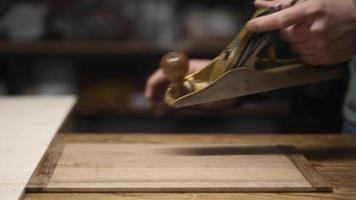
xmin=160 ymin=4 xmax=345 ymax=107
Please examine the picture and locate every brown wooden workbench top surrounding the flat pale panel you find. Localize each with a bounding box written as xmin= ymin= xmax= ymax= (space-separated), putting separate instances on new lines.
xmin=25 ymin=134 xmax=356 ymax=200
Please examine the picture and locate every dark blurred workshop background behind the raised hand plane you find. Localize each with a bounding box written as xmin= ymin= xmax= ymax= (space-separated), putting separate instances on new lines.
xmin=0 ymin=0 xmax=346 ymax=133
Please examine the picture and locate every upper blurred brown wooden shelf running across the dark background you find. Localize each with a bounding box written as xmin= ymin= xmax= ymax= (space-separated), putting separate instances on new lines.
xmin=0 ymin=39 xmax=228 ymax=55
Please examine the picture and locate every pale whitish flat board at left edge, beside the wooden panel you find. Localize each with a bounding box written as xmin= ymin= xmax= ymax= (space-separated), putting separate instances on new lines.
xmin=0 ymin=96 xmax=75 ymax=200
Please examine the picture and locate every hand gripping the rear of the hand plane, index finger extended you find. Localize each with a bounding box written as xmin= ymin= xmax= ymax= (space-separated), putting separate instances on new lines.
xmin=247 ymin=0 xmax=356 ymax=65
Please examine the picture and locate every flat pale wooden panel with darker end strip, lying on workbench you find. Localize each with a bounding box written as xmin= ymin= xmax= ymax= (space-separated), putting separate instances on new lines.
xmin=43 ymin=144 xmax=331 ymax=192
